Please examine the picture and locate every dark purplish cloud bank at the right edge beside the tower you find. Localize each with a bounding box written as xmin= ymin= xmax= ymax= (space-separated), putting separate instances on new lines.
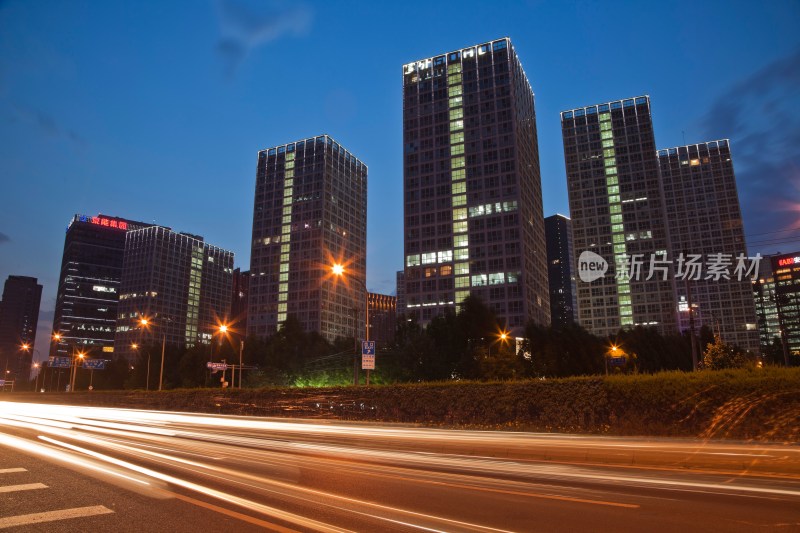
xmin=703 ymin=49 xmax=800 ymax=252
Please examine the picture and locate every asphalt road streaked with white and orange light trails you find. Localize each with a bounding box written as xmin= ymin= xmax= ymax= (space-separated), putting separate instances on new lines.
xmin=0 ymin=402 xmax=800 ymax=533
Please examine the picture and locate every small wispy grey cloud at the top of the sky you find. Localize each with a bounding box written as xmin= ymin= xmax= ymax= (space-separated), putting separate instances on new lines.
xmin=217 ymin=0 xmax=314 ymax=76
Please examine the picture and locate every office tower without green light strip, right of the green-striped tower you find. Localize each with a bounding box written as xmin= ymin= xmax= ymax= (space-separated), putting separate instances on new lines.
xmin=658 ymin=139 xmax=759 ymax=353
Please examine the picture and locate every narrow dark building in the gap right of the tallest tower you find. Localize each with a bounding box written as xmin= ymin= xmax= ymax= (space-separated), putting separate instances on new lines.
xmin=544 ymin=215 xmax=578 ymax=328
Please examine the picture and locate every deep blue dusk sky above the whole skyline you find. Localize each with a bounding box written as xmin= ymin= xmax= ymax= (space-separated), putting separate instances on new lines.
xmin=0 ymin=0 xmax=800 ymax=358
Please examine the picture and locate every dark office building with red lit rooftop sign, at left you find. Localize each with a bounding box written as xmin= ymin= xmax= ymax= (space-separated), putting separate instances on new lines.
xmin=50 ymin=215 xmax=149 ymax=358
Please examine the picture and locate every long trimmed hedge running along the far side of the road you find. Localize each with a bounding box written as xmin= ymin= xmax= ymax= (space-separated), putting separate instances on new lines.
xmin=9 ymin=368 xmax=800 ymax=442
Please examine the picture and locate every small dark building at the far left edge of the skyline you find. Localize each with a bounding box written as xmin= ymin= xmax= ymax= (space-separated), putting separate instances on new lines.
xmin=0 ymin=276 xmax=42 ymax=382
